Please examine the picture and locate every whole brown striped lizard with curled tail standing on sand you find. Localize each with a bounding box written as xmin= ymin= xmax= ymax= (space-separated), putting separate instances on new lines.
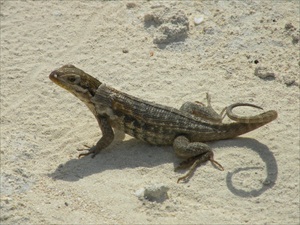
xmin=49 ymin=64 xmax=277 ymax=183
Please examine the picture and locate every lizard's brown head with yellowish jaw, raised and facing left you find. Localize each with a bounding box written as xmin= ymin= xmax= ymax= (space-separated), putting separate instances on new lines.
xmin=49 ymin=65 xmax=101 ymax=97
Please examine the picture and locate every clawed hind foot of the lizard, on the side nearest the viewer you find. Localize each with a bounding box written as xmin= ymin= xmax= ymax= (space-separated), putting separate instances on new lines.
xmin=175 ymin=151 xmax=224 ymax=183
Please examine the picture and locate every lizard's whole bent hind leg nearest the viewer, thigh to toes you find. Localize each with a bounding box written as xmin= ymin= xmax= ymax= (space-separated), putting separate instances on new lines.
xmin=173 ymin=136 xmax=224 ymax=183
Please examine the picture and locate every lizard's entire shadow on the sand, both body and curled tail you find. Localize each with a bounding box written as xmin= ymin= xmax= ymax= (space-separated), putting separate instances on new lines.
xmin=48 ymin=137 xmax=278 ymax=198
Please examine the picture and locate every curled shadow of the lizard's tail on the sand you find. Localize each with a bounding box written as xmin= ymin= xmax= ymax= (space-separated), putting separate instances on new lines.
xmin=211 ymin=137 xmax=278 ymax=198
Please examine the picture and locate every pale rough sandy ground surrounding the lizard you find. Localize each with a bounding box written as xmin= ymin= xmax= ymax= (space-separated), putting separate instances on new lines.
xmin=0 ymin=0 xmax=300 ymax=224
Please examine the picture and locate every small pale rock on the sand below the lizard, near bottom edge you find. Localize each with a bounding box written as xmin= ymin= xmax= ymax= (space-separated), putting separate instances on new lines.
xmin=135 ymin=184 xmax=169 ymax=202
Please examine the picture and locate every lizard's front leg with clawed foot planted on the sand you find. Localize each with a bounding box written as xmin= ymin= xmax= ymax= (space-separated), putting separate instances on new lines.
xmin=78 ymin=116 xmax=114 ymax=158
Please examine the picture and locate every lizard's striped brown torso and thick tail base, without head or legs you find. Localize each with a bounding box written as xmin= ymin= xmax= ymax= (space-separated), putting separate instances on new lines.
xmin=91 ymin=84 xmax=277 ymax=145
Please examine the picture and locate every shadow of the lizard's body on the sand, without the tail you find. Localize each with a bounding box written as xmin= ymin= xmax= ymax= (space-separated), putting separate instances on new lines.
xmin=48 ymin=138 xmax=178 ymax=182
